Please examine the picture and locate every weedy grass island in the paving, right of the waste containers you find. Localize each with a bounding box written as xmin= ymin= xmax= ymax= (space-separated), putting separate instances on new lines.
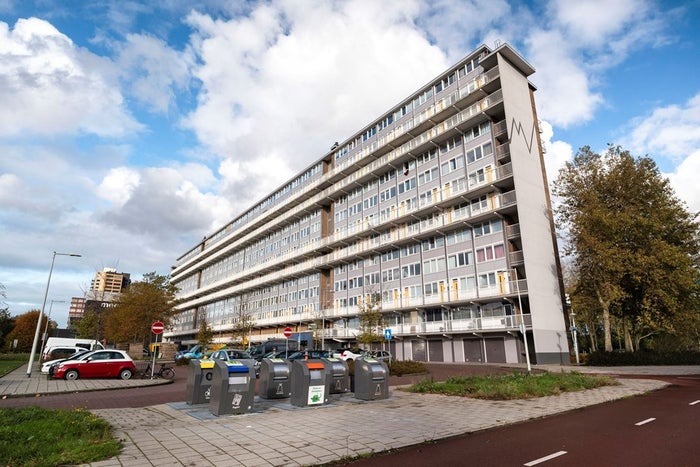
xmin=406 ymin=372 xmax=619 ymax=400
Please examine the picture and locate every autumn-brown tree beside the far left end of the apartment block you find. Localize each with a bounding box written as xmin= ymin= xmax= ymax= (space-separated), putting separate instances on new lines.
xmin=104 ymin=272 xmax=177 ymax=343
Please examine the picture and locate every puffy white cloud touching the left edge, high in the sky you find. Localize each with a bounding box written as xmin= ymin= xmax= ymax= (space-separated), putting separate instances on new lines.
xmin=0 ymin=18 xmax=141 ymax=136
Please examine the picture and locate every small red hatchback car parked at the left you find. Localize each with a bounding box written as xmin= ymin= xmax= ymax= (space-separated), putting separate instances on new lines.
xmin=54 ymin=349 xmax=136 ymax=380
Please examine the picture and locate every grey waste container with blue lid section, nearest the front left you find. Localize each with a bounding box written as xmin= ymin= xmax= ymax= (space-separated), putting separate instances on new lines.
xmin=209 ymin=360 xmax=255 ymax=415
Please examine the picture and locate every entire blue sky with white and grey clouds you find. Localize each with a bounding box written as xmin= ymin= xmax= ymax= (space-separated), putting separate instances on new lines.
xmin=0 ymin=0 xmax=700 ymax=327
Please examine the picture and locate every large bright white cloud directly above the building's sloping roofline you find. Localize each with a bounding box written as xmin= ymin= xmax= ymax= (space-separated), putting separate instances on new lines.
xmin=186 ymin=1 xmax=447 ymax=208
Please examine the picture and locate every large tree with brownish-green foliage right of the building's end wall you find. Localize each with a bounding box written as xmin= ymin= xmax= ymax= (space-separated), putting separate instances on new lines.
xmin=553 ymin=146 xmax=700 ymax=351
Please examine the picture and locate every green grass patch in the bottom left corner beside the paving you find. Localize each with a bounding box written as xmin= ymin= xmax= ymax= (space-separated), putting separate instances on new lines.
xmin=0 ymin=407 xmax=122 ymax=467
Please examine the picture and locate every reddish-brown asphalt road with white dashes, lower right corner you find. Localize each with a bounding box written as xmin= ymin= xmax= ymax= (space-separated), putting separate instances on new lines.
xmin=349 ymin=376 xmax=700 ymax=467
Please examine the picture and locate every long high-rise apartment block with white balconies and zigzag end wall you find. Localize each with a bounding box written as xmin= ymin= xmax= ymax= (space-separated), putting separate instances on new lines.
xmin=165 ymin=45 xmax=569 ymax=363
